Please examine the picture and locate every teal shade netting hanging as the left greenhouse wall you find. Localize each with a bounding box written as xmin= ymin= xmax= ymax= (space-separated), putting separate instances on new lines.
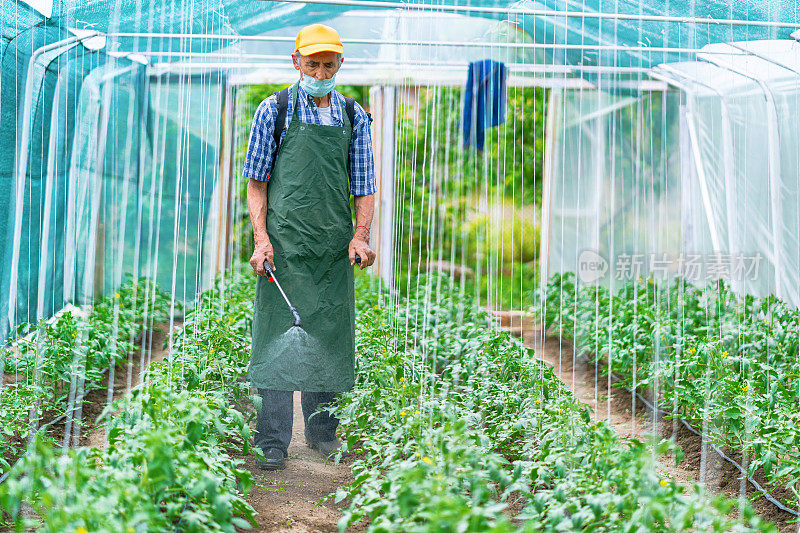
xmin=0 ymin=24 xmax=225 ymax=332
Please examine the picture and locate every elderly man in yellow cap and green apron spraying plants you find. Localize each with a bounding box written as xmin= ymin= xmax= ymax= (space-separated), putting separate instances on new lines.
xmin=244 ymin=24 xmax=376 ymax=470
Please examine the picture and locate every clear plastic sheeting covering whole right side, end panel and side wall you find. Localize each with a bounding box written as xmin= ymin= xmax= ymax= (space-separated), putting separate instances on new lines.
xmin=542 ymin=40 xmax=800 ymax=305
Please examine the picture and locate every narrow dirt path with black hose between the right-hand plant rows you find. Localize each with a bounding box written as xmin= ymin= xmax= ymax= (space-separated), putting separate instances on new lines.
xmin=524 ymin=331 xmax=800 ymax=533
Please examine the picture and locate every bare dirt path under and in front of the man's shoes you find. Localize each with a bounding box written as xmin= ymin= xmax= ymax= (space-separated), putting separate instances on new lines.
xmin=238 ymin=392 xmax=357 ymax=533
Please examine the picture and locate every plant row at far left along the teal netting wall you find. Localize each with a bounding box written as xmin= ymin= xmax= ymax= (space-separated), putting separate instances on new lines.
xmin=0 ymin=279 xmax=170 ymax=474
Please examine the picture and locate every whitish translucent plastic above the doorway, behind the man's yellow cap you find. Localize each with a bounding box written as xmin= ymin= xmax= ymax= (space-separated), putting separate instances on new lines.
xmin=222 ymin=10 xmax=540 ymax=85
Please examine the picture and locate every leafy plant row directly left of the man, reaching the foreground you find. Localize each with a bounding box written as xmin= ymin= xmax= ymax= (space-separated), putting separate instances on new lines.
xmin=0 ymin=274 xmax=255 ymax=533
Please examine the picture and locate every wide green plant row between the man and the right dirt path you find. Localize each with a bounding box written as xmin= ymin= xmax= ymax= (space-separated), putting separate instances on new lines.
xmin=336 ymin=277 xmax=774 ymax=532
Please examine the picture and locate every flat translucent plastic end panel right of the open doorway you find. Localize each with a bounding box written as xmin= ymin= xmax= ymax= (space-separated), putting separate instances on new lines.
xmin=541 ymin=90 xmax=683 ymax=284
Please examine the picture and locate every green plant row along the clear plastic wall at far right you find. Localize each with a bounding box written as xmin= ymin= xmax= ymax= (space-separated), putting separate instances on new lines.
xmin=545 ymin=274 xmax=800 ymax=511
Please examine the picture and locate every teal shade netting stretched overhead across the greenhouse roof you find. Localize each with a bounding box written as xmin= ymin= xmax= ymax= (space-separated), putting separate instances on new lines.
xmin=3 ymin=0 xmax=798 ymax=66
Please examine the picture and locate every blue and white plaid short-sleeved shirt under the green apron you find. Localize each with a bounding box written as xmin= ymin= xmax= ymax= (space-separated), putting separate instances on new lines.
xmin=242 ymin=86 xmax=377 ymax=196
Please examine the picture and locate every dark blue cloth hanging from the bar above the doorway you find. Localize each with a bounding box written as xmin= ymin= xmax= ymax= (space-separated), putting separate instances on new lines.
xmin=461 ymin=59 xmax=508 ymax=150
